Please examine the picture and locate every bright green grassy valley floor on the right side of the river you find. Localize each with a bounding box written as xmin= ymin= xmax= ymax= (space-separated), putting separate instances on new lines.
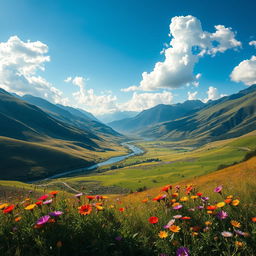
xmin=53 ymin=132 xmax=256 ymax=190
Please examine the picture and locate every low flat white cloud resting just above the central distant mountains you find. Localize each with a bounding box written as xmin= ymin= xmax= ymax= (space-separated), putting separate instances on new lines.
xmin=119 ymin=91 xmax=173 ymax=111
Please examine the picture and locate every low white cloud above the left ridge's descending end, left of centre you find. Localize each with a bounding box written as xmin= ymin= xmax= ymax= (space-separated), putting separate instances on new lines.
xmin=64 ymin=76 xmax=118 ymax=115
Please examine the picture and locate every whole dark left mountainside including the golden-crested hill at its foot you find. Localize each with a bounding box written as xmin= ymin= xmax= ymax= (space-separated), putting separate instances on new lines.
xmin=0 ymin=90 xmax=126 ymax=180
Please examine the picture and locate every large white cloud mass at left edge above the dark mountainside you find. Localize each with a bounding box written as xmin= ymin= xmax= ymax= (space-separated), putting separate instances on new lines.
xmin=0 ymin=36 xmax=67 ymax=104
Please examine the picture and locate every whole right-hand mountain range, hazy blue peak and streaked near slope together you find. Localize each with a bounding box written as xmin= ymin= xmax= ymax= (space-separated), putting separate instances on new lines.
xmin=109 ymin=85 xmax=256 ymax=145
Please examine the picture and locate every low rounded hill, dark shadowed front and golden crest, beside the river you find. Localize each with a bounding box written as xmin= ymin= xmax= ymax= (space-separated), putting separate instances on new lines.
xmin=0 ymin=137 xmax=127 ymax=180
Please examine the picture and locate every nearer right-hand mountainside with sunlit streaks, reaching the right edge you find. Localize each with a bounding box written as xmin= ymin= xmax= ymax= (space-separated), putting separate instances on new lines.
xmin=139 ymin=85 xmax=256 ymax=144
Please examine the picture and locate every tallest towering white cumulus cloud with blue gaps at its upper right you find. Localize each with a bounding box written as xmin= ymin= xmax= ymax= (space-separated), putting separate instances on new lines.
xmin=125 ymin=15 xmax=241 ymax=91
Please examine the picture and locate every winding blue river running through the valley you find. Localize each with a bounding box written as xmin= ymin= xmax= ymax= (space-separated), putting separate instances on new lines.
xmin=30 ymin=142 xmax=144 ymax=183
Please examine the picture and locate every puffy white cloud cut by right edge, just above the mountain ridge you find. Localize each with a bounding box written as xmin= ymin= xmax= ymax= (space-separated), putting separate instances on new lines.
xmin=230 ymin=56 xmax=256 ymax=85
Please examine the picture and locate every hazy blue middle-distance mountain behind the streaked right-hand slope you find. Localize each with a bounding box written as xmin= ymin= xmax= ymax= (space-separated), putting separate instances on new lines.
xmin=108 ymin=100 xmax=204 ymax=133
